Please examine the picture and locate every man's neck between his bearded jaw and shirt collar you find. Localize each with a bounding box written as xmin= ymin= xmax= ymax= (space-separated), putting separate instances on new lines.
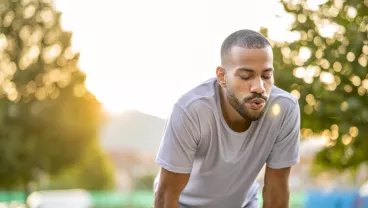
xmin=218 ymin=86 xmax=251 ymax=132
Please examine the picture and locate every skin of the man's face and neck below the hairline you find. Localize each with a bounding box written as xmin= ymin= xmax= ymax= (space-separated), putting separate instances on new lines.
xmin=216 ymin=46 xmax=274 ymax=132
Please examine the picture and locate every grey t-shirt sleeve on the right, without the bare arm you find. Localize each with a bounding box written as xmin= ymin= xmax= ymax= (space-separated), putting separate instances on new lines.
xmin=267 ymin=103 xmax=300 ymax=169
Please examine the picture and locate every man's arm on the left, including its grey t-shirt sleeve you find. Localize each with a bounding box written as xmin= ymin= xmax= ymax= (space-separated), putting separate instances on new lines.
xmin=154 ymin=104 xmax=200 ymax=208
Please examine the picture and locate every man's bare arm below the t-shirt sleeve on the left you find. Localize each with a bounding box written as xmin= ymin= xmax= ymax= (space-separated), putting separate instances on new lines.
xmin=154 ymin=168 xmax=189 ymax=208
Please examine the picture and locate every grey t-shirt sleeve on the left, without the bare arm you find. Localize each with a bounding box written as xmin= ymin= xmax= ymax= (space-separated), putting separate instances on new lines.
xmin=156 ymin=104 xmax=199 ymax=173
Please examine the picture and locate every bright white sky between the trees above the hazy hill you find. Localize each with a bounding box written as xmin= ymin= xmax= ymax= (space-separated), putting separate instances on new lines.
xmin=56 ymin=0 xmax=292 ymax=118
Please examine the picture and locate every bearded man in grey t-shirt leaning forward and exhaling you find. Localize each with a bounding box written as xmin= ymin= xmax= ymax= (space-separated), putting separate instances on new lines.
xmin=154 ymin=30 xmax=300 ymax=208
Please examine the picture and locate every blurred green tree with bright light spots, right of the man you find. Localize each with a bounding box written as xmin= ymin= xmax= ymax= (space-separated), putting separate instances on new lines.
xmin=262 ymin=0 xmax=368 ymax=170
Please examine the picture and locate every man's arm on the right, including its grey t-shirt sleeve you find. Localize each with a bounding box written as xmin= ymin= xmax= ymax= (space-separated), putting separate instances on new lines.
xmin=263 ymin=103 xmax=300 ymax=208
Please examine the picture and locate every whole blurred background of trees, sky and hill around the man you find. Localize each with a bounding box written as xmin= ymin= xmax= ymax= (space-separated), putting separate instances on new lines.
xmin=0 ymin=0 xmax=368 ymax=208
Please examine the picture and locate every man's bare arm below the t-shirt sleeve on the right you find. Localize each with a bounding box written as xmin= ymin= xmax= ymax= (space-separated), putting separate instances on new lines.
xmin=263 ymin=166 xmax=291 ymax=208
